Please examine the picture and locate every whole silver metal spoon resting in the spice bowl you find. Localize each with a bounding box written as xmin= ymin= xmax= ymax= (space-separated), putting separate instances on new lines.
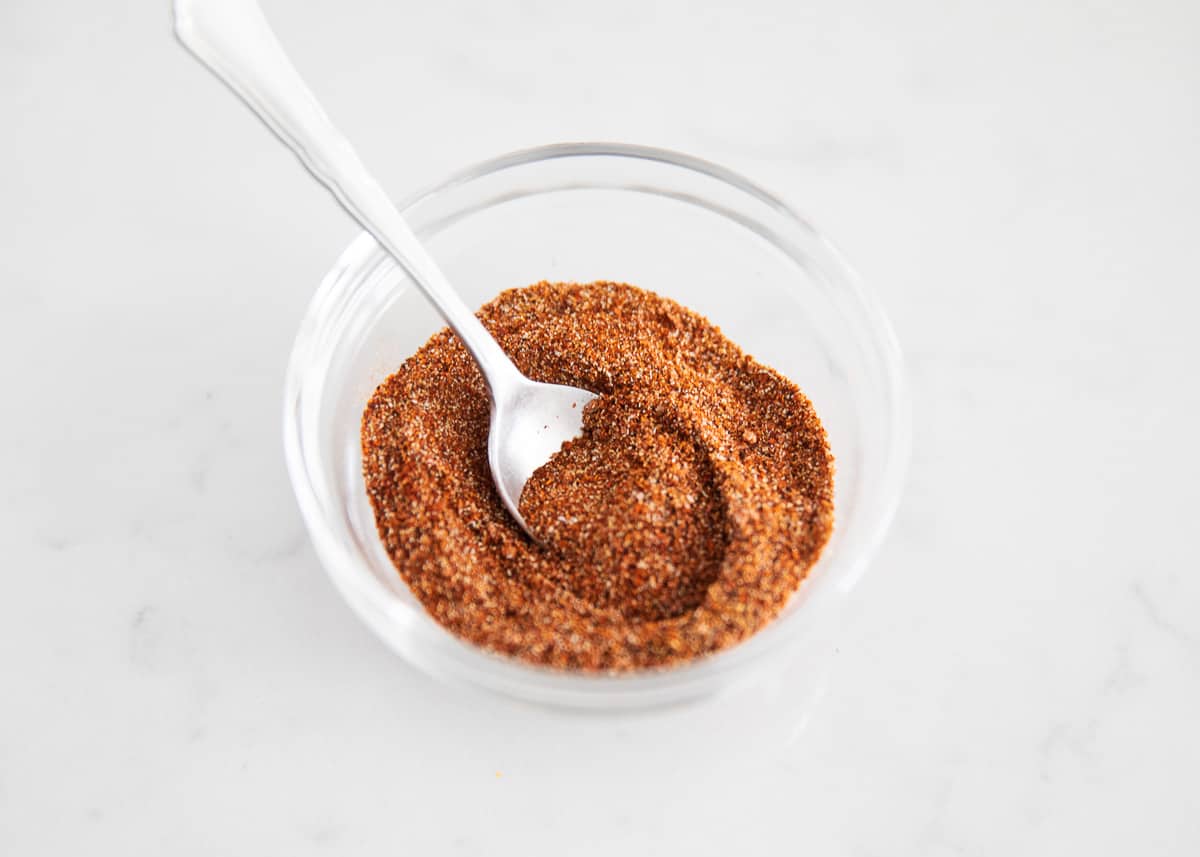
xmin=175 ymin=0 xmax=595 ymax=533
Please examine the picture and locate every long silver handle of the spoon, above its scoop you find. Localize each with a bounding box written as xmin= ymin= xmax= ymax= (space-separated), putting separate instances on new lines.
xmin=175 ymin=0 xmax=520 ymax=386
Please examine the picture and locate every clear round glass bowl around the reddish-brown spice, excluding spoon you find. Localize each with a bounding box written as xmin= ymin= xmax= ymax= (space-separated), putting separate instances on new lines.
xmin=283 ymin=144 xmax=910 ymax=708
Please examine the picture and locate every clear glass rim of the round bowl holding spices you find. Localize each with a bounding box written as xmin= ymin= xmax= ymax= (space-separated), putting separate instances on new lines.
xmin=283 ymin=142 xmax=911 ymax=707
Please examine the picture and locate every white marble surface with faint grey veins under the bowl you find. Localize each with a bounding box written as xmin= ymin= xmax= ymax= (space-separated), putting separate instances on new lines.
xmin=0 ymin=0 xmax=1200 ymax=857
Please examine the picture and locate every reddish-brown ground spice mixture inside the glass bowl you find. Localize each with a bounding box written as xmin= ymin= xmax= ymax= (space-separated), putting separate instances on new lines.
xmin=362 ymin=282 xmax=833 ymax=671
